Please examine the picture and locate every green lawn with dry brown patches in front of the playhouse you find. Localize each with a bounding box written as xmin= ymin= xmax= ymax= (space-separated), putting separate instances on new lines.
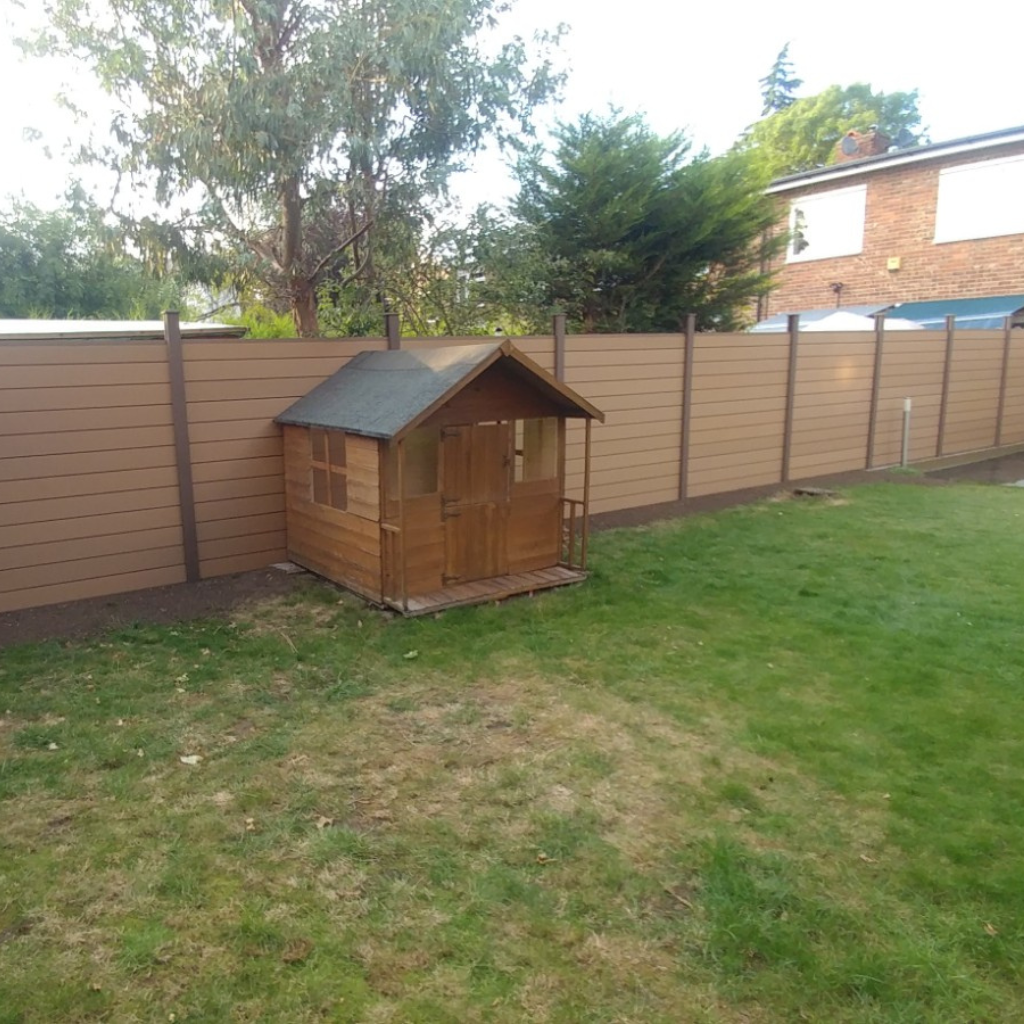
xmin=0 ymin=484 xmax=1024 ymax=1024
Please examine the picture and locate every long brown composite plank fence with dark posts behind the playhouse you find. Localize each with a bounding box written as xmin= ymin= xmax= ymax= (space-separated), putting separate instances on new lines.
xmin=0 ymin=315 xmax=1024 ymax=611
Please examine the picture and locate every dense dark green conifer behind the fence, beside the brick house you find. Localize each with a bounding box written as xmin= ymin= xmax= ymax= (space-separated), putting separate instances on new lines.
xmin=505 ymin=112 xmax=778 ymax=332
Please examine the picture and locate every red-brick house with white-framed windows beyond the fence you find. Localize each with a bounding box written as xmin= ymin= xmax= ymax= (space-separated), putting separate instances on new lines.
xmin=758 ymin=126 xmax=1024 ymax=321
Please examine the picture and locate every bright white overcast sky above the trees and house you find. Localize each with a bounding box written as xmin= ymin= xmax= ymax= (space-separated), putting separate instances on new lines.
xmin=0 ymin=0 xmax=1024 ymax=206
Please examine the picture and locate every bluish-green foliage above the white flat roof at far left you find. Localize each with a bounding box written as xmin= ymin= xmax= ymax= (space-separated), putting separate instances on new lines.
xmin=0 ymin=191 xmax=181 ymax=319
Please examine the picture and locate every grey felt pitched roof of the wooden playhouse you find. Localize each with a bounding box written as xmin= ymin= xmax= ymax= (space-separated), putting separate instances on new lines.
xmin=278 ymin=340 xmax=604 ymax=438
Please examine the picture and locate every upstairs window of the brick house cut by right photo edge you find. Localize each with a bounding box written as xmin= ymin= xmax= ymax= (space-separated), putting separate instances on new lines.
xmin=935 ymin=157 xmax=1024 ymax=242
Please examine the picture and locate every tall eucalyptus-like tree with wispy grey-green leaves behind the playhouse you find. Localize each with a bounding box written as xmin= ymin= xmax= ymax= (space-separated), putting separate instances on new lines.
xmin=25 ymin=0 xmax=560 ymax=334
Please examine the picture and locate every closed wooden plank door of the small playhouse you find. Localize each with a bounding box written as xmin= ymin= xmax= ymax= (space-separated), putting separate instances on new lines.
xmin=441 ymin=423 xmax=512 ymax=586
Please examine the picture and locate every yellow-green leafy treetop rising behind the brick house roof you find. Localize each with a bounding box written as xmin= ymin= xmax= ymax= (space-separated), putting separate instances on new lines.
xmin=737 ymin=84 xmax=923 ymax=179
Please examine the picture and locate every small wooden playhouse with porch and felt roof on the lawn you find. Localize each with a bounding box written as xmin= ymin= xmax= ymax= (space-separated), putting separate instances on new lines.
xmin=278 ymin=341 xmax=603 ymax=614
